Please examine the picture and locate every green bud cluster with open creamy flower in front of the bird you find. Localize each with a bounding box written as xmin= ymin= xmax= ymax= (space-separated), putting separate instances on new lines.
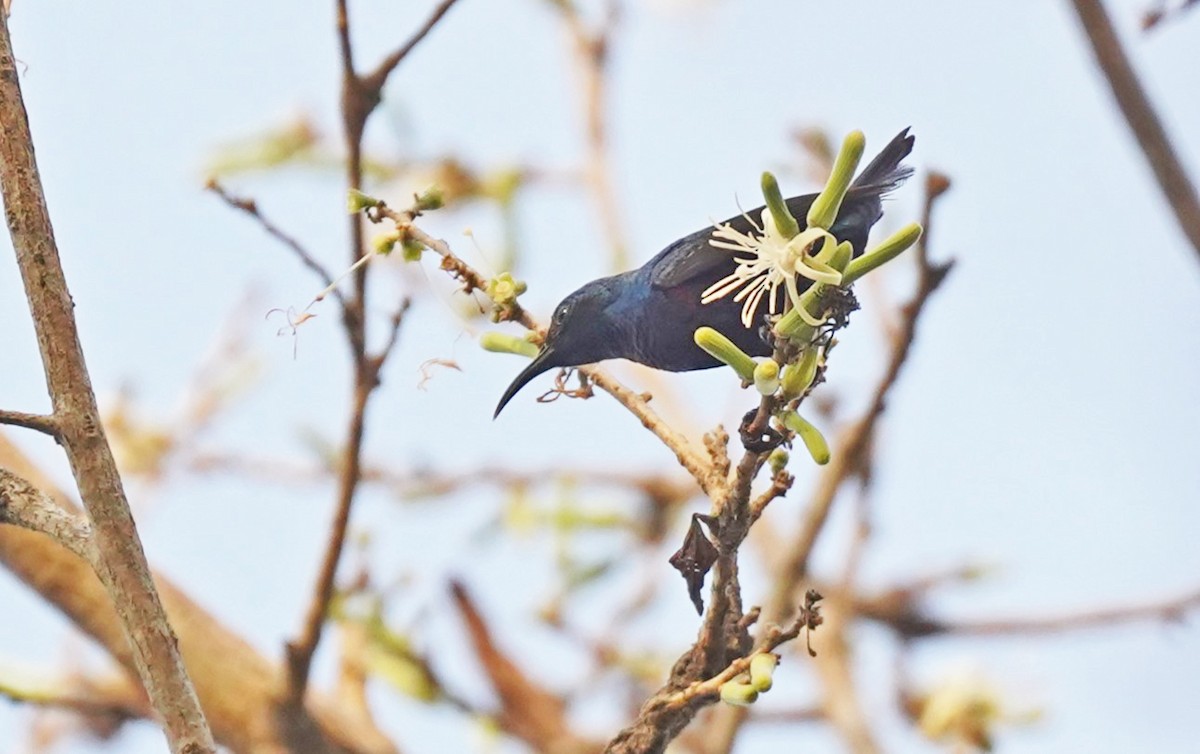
xmin=695 ymin=131 xmax=922 ymax=463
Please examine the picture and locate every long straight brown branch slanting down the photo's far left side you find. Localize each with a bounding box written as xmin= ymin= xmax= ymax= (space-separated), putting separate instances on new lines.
xmin=0 ymin=14 xmax=216 ymax=754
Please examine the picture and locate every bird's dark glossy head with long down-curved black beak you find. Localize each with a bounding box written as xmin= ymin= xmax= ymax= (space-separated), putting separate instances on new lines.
xmin=492 ymin=277 xmax=622 ymax=419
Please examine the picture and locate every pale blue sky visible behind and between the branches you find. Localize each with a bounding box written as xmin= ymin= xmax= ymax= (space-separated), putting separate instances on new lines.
xmin=0 ymin=0 xmax=1200 ymax=754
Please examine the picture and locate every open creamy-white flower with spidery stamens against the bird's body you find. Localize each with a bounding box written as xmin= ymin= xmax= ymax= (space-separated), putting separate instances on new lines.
xmin=700 ymin=209 xmax=841 ymax=328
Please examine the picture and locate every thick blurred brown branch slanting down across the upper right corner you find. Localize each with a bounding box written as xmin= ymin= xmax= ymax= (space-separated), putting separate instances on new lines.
xmin=1072 ymin=0 xmax=1200 ymax=264
